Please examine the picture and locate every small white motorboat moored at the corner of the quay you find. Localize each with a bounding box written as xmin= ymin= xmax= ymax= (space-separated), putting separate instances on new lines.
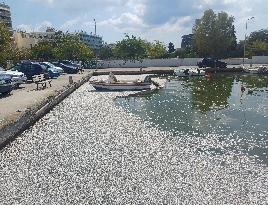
xmin=90 ymin=73 xmax=152 ymax=91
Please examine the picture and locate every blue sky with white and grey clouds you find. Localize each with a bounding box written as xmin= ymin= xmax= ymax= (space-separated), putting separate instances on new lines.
xmin=2 ymin=0 xmax=268 ymax=47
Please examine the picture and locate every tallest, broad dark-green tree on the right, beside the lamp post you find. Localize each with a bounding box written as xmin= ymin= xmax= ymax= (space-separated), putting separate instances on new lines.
xmin=193 ymin=9 xmax=236 ymax=58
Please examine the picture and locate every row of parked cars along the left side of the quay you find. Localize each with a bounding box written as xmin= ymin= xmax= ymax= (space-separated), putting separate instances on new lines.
xmin=0 ymin=60 xmax=81 ymax=94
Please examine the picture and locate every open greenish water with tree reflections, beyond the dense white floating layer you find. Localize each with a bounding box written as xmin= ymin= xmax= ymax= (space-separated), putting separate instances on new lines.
xmin=116 ymin=74 xmax=268 ymax=164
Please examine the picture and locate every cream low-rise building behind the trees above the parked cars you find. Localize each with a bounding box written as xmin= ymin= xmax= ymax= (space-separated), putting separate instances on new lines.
xmin=13 ymin=30 xmax=56 ymax=49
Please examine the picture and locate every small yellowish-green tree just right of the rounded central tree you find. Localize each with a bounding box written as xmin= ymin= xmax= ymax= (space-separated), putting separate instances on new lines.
xmin=146 ymin=41 xmax=167 ymax=59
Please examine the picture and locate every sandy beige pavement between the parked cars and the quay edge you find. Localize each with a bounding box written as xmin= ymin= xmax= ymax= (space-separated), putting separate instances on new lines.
xmin=0 ymin=70 xmax=92 ymax=128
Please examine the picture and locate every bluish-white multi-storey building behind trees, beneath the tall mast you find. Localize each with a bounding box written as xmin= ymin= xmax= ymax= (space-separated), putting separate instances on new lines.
xmin=78 ymin=31 xmax=103 ymax=49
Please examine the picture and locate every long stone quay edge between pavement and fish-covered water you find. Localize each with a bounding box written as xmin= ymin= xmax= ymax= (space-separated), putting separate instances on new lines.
xmin=0 ymin=73 xmax=93 ymax=149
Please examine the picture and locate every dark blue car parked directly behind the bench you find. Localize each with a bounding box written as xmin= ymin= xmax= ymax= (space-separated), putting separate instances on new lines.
xmin=11 ymin=61 xmax=49 ymax=80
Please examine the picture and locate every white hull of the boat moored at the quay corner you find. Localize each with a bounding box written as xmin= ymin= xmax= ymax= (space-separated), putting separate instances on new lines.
xmin=91 ymin=83 xmax=151 ymax=91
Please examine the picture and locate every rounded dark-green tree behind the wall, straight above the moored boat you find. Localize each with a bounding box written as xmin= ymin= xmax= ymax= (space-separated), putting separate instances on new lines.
xmin=115 ymin=35 xmax=146 ymax=60
